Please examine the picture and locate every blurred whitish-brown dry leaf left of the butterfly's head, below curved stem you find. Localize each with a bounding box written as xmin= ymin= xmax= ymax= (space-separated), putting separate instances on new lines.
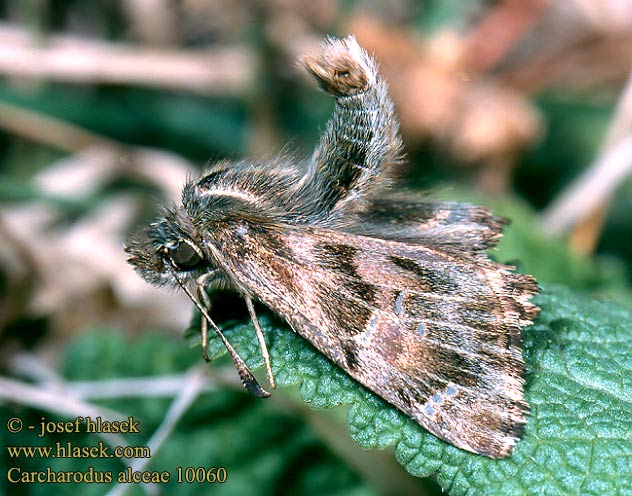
xmin=2 ymin=197 xmax=190 ymax=340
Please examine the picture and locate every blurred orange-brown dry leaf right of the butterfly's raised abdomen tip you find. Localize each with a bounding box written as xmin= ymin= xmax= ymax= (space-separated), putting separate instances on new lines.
xmin=349 ymin=15 xmax=542 ymax=192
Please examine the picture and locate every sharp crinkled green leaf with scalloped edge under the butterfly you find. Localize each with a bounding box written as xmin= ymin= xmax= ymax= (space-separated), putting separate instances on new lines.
xmin=200 ymin=285 xmax=632 ymax=495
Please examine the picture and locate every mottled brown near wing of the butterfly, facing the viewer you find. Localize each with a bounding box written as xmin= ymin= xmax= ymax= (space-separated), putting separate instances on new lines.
xmin=215 ymin=223 xmax=538 ymax=457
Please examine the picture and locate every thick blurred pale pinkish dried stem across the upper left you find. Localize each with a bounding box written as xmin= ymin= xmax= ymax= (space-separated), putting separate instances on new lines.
xmin=0 ymin=24 xmax=255 ymax=95
